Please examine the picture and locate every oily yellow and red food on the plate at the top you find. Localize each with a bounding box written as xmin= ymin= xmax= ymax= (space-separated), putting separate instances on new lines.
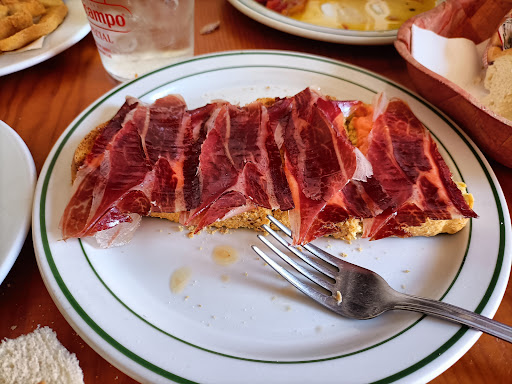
xmin=256 ymin=0 xmax=436 ymax=31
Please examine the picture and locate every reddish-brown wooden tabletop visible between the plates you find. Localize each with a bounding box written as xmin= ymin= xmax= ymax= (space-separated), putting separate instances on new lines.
xmin=0 ymin=0 xmax=512 ymax=384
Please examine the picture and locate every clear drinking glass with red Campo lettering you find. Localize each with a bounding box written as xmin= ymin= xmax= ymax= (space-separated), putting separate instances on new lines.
xmin=82 ymin=0 xmax=194 ymax=81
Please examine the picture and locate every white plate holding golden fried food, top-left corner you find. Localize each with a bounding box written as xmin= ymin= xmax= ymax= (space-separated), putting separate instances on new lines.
xmin=0 ymin=0 xmax=91 ymax=76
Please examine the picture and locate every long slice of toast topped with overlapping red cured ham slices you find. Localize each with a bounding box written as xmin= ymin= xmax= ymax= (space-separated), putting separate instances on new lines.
xmin=61 ymin=88 xmax=476 ymax=247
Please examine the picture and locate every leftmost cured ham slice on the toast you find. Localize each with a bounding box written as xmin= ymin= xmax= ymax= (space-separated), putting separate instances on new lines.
xmin=61 ymin=103 xmax=150 ymax=244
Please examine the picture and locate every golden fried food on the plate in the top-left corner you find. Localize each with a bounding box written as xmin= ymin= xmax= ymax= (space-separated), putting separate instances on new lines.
xmin=0 ymin=0 xmax=68 ymax=53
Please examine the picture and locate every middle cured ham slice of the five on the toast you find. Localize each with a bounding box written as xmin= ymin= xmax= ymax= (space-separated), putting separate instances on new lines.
xmin=181 ymin=102 xmax=293 ymax=232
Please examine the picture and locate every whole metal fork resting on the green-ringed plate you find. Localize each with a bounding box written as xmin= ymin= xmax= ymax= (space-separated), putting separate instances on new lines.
xmin=252 ymin=216 xmax=512 ymax=342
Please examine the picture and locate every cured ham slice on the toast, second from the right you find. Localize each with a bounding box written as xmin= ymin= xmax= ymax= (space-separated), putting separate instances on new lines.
xmin=279 ymin=88 xmax=371 ymax=244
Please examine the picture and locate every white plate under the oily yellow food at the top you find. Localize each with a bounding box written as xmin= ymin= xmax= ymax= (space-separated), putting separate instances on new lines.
xmin=228 ymin=0 xmax=398 ymax=45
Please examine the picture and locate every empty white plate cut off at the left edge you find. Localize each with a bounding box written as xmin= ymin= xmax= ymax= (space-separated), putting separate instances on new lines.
xmin=0 ymin=120 xmax=36 ymax=284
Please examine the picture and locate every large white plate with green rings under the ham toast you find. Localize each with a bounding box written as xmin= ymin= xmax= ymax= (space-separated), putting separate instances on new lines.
xmin=33 ymin=51 xmax=511 ymax=383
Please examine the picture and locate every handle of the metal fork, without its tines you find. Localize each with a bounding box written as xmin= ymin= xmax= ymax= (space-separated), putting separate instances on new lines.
xmin=393 ymin=295 xmax=512 ymax=343
